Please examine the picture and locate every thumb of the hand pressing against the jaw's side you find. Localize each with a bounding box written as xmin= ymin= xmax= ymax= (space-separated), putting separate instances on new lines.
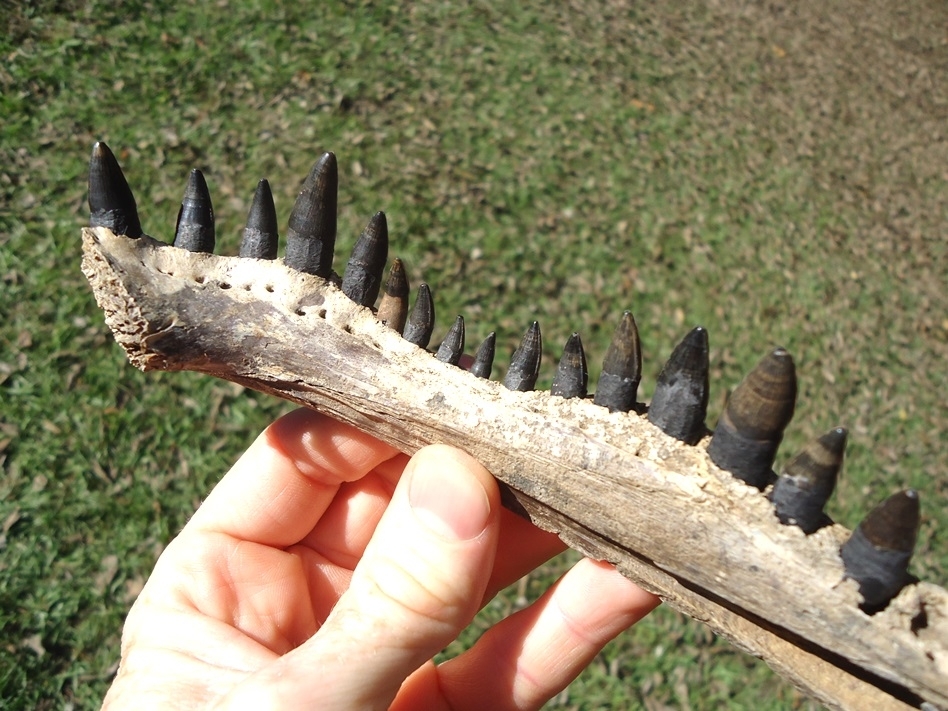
xmin=223 ymin=445 xmax=500 ymax=709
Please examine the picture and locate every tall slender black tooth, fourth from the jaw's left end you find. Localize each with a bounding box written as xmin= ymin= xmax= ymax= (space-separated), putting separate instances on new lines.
xmin=285 ymin=153 xmax=339 ymax=279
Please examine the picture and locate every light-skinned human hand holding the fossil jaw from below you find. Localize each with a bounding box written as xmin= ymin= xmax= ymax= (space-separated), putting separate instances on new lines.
xmin=105 ymin=410 xmax=658 ymax=711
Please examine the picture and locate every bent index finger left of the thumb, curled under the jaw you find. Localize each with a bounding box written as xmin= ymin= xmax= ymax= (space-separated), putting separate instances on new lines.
xmin=185 ymin=409 xmax=398 ymax=548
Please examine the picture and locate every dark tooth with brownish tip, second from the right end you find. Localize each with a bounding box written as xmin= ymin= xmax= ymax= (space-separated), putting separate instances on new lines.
xmin=770 ymin=427 xmax=847 ymax=533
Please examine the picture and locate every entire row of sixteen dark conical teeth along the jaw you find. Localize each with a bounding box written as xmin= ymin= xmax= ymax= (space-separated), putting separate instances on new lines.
xmin=89 ymin=142 xmax=919 ymax=613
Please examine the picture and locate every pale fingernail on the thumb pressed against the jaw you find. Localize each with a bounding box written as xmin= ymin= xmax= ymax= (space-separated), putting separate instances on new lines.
xmin=408 ymin=466 xmax=490 ymax=541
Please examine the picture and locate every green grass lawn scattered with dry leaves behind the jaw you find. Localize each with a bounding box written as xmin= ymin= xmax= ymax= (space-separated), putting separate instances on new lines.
xmin=0 ymin=0 xmax=948 ymax=709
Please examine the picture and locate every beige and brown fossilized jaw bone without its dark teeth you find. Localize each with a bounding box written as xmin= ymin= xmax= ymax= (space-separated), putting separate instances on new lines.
xmin=83 ymin=145 xmax=948 ymax=708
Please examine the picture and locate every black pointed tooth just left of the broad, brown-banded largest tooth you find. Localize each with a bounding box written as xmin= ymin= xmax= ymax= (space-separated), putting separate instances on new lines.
xmin=648 ymin=326 xmax=709 ymax=444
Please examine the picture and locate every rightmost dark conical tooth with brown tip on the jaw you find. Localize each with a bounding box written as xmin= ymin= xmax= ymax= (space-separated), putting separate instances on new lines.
xmin=840 ymin=489 xmax=919 ymax=614
